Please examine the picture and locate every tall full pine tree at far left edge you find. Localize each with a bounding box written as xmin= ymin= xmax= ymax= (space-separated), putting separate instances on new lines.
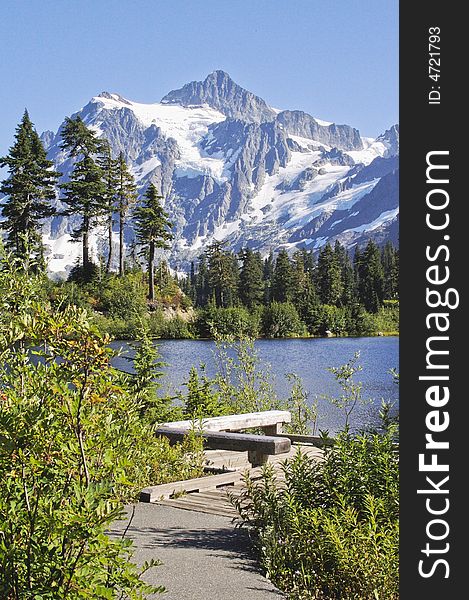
xmin=0 ymin=110 xmax=60 ymax=261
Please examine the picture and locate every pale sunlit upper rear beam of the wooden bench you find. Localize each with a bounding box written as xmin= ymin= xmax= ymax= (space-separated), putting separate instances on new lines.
xmin=161 ymin=410 xmax=291 ymax=431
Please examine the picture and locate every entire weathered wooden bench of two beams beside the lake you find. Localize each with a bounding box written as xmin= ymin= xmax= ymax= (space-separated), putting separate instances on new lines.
xmin=156 ymin=410 xmax=291 ymax=467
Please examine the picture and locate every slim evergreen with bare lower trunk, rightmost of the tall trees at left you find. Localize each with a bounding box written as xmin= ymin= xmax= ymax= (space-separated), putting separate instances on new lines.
xmin=134 ymin=183 xmax=173 ymax=302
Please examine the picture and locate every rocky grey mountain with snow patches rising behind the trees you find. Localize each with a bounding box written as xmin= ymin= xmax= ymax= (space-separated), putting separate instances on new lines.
xmin=36 ymin=71 xmax=399 ymax=272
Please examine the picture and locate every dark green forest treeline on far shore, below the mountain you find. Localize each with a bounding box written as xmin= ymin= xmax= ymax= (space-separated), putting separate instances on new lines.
xmin=180 ymin=240 xmax=399 ymax=337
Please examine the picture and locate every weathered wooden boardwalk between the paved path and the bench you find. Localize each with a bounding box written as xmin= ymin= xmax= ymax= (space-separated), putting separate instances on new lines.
xmin=147 ymin=444 xmax=323 ymax=518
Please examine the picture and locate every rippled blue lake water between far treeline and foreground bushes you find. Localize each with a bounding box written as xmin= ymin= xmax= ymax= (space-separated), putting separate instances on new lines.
xmin=112 ymin=337 xmax=399 ymax=434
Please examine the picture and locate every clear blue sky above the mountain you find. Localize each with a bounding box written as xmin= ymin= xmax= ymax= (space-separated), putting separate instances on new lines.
xmin=0 ymin=0 xmax=398 ymax=155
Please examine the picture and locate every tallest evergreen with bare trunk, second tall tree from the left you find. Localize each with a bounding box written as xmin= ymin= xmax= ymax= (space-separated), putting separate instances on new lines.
xmin=61 ymin=116 xmax=107 ymax=277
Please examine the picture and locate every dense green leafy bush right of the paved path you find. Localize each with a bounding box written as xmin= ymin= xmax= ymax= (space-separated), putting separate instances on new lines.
xmin=232 ymin=434 xmax=399 ymax=600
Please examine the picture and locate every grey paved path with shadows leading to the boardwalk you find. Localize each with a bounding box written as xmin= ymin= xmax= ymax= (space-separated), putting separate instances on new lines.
xmin=113 ymin=503 xmax=284 ymax=600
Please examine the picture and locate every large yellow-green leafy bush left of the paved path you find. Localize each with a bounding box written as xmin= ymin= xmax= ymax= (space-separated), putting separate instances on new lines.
xmin=0 ymin=248 xmax=201 ymax=600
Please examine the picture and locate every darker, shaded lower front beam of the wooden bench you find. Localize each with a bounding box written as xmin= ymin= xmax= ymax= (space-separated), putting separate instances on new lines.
xmin=156 ymin=427 xmax=291 ymax=454
